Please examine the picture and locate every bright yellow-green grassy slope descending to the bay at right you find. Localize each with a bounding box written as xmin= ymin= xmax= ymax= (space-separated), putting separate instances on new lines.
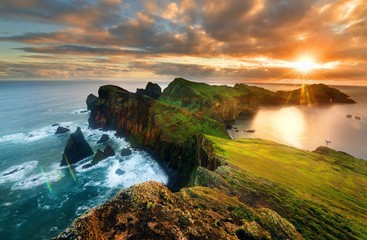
xmin=208 ymin=136 xmax=367 ymax=239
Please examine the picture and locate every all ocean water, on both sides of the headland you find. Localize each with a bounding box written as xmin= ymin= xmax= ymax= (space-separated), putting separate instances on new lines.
xmin=0 ymin=81 xmax=367 ymax=239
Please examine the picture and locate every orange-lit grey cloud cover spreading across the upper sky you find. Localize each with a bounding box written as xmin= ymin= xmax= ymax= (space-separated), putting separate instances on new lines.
xmin=0 ymin=0 xmax=367 ymax=82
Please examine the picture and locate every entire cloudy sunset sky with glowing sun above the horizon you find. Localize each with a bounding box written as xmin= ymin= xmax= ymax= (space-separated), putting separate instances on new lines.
xmin=0 ymin=0 xmax=367 ymax=85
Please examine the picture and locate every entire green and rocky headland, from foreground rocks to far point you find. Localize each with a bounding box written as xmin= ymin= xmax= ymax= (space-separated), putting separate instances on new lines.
xmin=56 ymin=78 xmax=367 ymax=239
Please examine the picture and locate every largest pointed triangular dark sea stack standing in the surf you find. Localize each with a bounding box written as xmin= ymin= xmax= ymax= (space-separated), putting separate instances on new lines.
xmin=60 ymin=127 xmax=93 ymax=166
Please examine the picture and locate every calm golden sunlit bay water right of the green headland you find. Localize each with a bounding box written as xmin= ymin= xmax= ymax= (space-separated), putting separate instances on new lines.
xmin=229 ymin=84 xmax=367 ymax=160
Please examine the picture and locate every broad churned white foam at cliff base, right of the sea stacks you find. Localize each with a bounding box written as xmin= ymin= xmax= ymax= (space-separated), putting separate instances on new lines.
xmin=106 ymin=153 xmax=168 ymax=188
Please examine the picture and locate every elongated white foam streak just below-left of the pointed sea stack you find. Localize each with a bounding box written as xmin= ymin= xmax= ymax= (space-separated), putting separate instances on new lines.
xmin=11 ymin=169 xmax=64 ymax=190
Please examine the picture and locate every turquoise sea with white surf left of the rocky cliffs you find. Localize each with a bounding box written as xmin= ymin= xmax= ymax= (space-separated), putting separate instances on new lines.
xmin=0 ymin=81 xmax=168 ymax=239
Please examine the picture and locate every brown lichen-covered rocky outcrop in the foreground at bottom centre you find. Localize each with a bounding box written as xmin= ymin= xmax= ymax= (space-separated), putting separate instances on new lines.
xmin=56 ymin=181 xmax=303 ymax=240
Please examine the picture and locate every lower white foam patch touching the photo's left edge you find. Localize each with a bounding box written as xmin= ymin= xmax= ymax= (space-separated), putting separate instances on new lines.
xmin=0 ymin=161 xmax=38 ymax=184
